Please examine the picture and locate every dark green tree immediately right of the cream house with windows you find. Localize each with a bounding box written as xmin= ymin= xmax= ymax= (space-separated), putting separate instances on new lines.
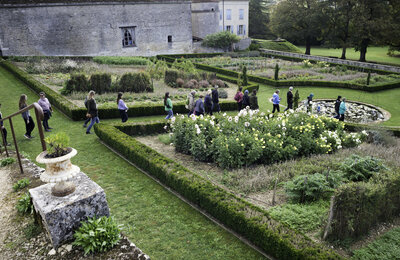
xmin=249 ymin=0 xmax=274 ymax=39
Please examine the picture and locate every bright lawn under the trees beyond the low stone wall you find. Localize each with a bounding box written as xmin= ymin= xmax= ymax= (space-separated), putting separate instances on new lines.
xmin=299 ymin=46 xmax=400 ymax=65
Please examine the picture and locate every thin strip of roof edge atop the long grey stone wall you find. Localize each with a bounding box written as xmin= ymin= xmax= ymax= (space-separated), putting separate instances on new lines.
xmin=0 ymin=0 xmax=190 ymax=5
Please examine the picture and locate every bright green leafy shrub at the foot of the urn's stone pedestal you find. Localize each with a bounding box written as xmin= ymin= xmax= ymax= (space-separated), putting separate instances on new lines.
xmin=73 ymin=216 xmax=121 ymax=255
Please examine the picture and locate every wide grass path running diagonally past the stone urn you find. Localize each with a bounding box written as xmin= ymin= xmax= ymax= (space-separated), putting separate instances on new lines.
xmin=0 ymin=68 xmax=263 ymax=259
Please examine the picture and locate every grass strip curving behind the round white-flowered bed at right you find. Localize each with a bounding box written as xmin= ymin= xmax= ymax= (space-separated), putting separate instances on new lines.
xmin=257 ymin=85 xmax=400 ymax=126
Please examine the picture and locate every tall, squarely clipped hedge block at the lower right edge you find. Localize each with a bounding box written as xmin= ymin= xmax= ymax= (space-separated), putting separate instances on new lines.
xmin=329 ymin=172 xmax=400 ymax=239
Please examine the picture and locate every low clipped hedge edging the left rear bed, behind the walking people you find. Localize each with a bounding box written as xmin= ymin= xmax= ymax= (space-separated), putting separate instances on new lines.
xmin=0 ymin=59 xmax=238 ymax=121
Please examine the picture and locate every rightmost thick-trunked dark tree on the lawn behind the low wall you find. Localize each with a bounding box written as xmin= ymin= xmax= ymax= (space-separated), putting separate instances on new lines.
xmin=352 ymin=0 xmax=391 ymax=61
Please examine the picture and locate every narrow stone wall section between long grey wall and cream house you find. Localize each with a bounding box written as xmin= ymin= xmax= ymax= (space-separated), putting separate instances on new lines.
xmin=192 ymin=1 xmax=219 ymax=39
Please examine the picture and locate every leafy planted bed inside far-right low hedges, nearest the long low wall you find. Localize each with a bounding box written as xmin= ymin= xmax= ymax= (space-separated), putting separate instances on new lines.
xmin=191 ymin=56 xmax=400 ymax=86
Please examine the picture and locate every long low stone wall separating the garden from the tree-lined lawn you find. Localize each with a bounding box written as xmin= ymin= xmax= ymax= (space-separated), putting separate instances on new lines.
xmin=260 ymin=49 xmax=400 ymax=73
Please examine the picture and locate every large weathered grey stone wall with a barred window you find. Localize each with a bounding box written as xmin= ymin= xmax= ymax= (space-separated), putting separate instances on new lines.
xmin=0 ymin=0 xmax=192 ymax=56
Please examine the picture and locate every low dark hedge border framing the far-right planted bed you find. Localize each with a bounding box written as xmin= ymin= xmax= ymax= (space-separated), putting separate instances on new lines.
xmin=157 ymin=53 xmax=400 ymax=92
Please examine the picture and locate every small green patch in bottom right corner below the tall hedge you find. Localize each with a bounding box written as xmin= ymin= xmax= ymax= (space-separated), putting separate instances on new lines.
xmin=351 ymin=228 xmax=400 ymax=260
